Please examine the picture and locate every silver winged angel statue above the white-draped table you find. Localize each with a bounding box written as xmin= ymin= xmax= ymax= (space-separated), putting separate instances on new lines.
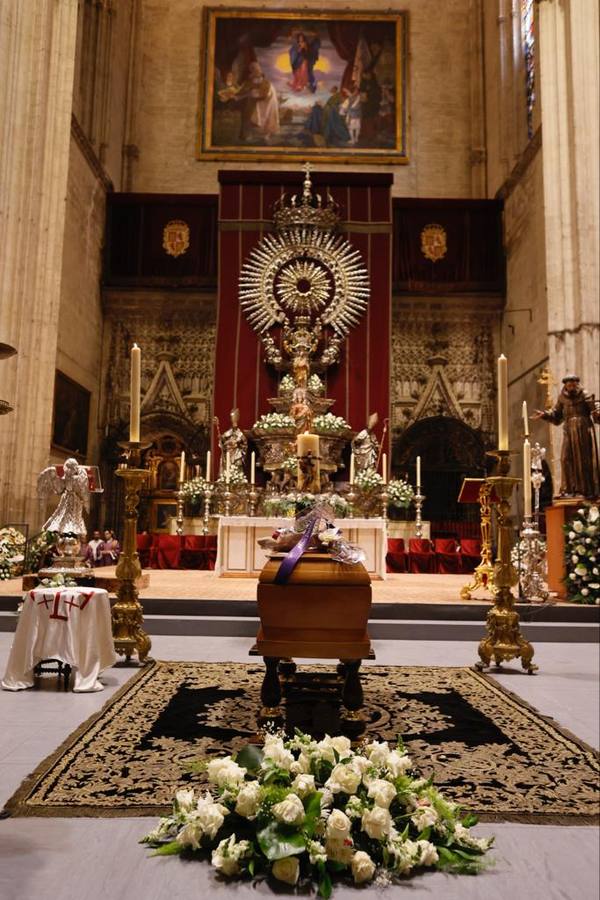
xmin=38 ymin=458 xmax=90 ymax=540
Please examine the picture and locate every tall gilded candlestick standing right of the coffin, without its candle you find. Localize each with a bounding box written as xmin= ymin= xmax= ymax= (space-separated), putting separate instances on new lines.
xmin=475 ymin=450 xmax=537 ymax=675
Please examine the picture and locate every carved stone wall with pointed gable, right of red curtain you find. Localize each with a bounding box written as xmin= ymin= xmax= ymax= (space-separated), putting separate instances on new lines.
xmin=391 ymin=310 xmax=495 ymax=446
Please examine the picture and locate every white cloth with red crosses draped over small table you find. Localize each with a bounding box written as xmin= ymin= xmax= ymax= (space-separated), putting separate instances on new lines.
xmin=2 ymin=587 xmax=117 ymax=693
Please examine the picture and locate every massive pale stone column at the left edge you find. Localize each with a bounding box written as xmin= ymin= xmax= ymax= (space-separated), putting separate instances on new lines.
xmin=0 ymin=0 xmax=77 ymax=528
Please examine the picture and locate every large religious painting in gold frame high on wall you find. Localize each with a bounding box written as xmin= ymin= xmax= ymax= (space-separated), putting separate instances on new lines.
xmin=197 ymin=7 xmax=408 ymax=164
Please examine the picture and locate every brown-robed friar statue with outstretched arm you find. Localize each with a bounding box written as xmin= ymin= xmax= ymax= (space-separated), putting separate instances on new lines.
xmin=532 ymin=375 xmax=600 ymax=498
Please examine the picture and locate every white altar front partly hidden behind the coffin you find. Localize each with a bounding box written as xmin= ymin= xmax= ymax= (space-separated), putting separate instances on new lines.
xmin=215 ymin=516 xmax=387 ymax=578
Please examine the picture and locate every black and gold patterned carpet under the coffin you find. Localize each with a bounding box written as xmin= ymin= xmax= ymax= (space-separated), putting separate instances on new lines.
xmin=4 ymin=662 xmax=599 ymax=825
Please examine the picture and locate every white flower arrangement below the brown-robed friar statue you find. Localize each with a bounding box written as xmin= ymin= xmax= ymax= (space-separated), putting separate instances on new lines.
xmin=564 ymin=504 xmax=600 ymax=606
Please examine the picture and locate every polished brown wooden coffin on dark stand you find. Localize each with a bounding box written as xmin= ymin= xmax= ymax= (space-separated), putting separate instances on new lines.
xmin=256 ymin=553 xmax=371 ymax=659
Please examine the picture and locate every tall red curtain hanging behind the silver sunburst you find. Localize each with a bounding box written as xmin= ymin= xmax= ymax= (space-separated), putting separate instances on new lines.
xmin=214 ymin=171 xmax=392 ymax=474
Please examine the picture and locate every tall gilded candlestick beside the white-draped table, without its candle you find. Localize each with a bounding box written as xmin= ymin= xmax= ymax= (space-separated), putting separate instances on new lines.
xmin=112 ymin=441 xmax=152 ymax=663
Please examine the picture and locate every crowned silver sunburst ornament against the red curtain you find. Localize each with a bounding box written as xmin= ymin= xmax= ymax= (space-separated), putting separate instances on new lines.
xmin=239 ymin=163 xmax=369 ymax=366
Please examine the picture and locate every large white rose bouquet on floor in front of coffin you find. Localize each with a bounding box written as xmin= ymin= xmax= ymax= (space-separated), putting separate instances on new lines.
xmin=142 ymin=732 xmax=493 ymax=898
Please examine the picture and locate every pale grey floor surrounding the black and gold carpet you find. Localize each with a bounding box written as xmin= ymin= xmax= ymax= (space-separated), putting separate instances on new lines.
xmin=0 ymin=634 xmax=600 ymax=900
